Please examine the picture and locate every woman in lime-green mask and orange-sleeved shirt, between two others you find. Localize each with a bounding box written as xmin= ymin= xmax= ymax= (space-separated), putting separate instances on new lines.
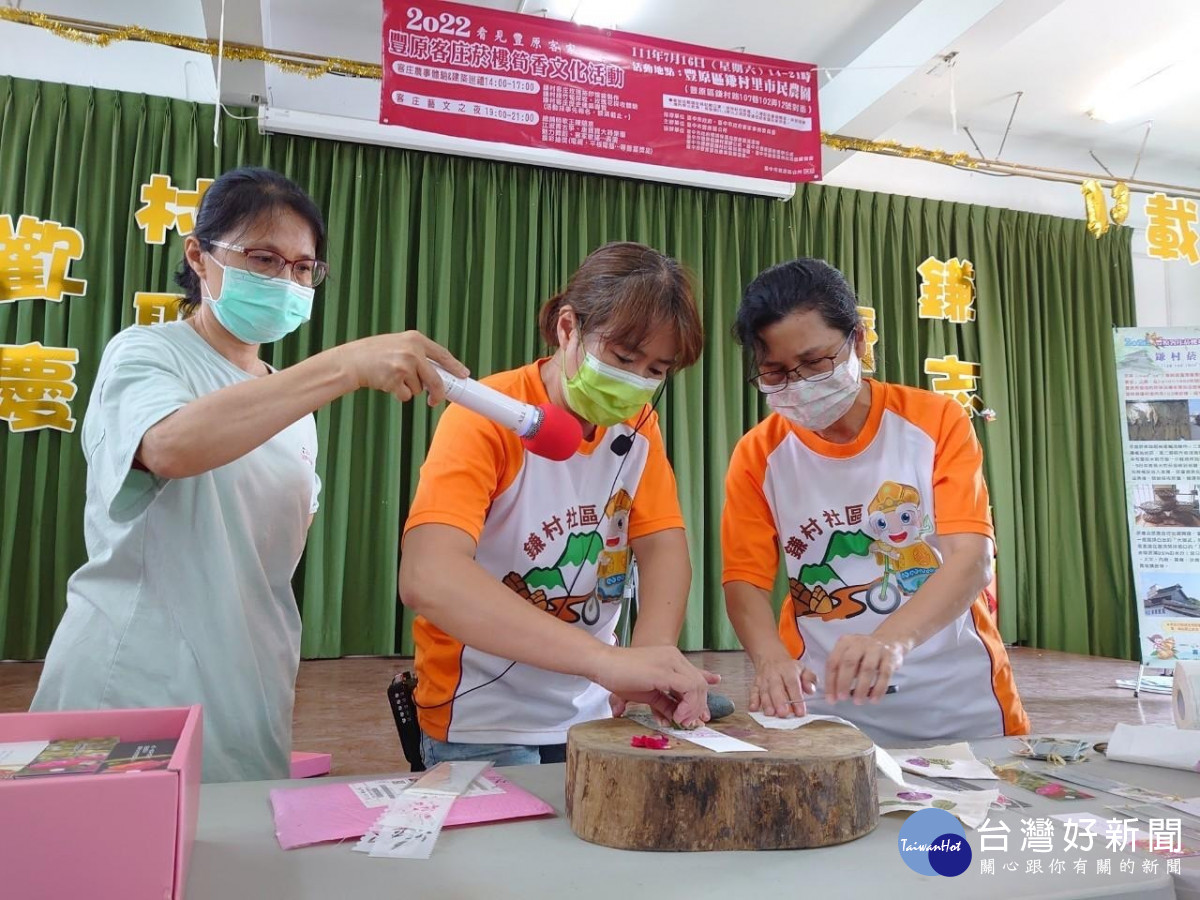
xmin=400 ymin=244 xmax=716 ymax=766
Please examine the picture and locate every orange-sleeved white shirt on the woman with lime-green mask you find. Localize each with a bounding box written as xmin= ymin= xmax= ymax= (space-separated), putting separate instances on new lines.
xmin=404 ymin=360 xmax=684 ymax=744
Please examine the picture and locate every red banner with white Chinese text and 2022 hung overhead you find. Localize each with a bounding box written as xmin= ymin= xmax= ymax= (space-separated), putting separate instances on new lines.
xmin=379 ymin=0 xmax=821 ymax=181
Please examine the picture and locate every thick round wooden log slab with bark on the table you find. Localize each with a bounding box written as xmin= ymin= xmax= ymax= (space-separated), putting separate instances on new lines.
xmin=566 ymin=713 xmax=880 ymax=851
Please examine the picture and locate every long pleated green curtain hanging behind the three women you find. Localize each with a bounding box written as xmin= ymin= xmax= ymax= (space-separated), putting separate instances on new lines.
xmin=0 ymin=78 xmax=1134 ymax=659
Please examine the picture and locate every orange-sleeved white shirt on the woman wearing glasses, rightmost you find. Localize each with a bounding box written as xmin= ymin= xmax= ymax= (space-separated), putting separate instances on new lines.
xmin=721 ymin=380 xmax=1030 ymax=746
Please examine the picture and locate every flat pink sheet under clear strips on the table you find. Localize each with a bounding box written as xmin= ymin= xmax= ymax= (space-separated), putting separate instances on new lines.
xmin=271 ymin=769 xmax=554 ymax=850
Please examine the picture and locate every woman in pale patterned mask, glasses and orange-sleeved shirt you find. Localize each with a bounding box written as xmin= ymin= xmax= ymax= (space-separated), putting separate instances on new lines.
xmin=721 ymin=259 xmax=1030 ymax=745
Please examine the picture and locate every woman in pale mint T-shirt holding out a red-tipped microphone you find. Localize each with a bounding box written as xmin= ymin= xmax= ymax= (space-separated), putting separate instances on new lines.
xmin=32 ymin=169 xmax=467 ymax=781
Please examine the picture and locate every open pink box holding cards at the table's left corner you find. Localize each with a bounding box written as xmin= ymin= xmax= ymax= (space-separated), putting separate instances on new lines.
xmin=0 ymin=706 xmax=203 ymax=900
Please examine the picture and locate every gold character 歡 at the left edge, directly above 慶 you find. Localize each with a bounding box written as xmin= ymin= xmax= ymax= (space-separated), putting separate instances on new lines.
xmin=0 ymin=215 xmax=88 ymax=304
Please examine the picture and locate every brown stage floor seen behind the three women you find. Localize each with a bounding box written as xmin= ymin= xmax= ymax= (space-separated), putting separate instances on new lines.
xmin=0 ymin=648 xmax=1171 ymax=775
